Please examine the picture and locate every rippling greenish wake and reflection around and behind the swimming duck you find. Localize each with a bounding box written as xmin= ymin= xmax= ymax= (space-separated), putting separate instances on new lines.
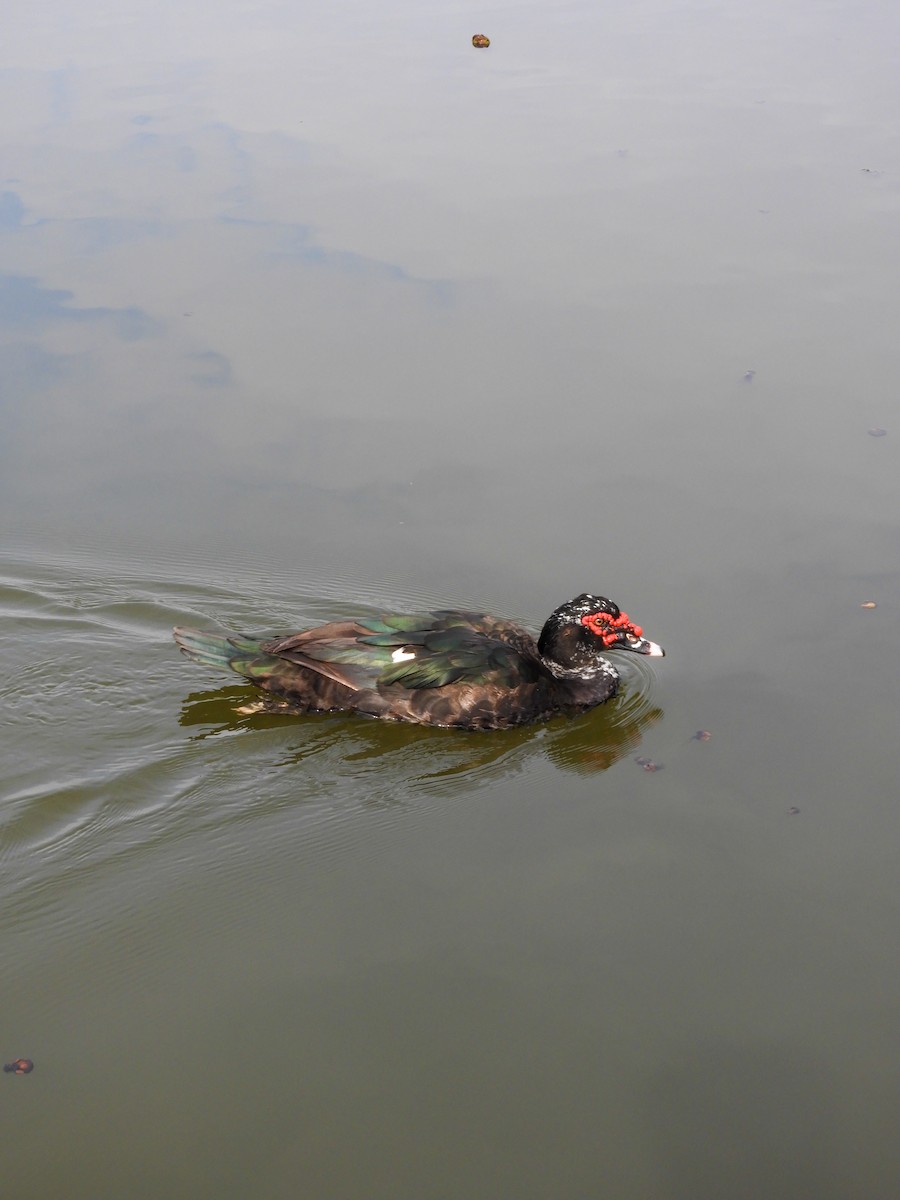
xmin=0 ymin=547 xmax=659 ymax=929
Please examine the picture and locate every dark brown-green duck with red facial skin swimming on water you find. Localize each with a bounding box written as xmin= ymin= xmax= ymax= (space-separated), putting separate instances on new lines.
xmin=173 ymin=592 xmax=665 ymax=730
